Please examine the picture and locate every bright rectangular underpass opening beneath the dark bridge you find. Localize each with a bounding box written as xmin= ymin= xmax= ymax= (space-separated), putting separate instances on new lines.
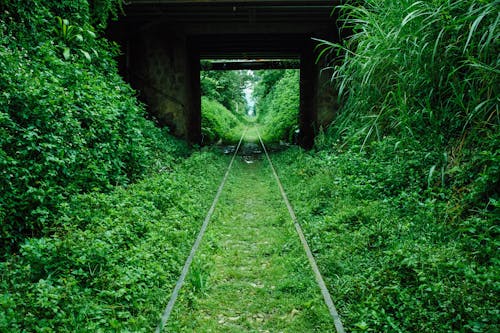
xmin=200 ymin=58 xmax=300 ymax=144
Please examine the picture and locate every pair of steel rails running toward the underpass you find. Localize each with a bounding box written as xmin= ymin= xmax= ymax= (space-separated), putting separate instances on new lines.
xmin=155 ymin=130 xmax=345 ymax=333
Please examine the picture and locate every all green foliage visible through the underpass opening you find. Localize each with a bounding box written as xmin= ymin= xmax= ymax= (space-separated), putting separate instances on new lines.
xmin=201 ymin=70 xmax=300 ymax=143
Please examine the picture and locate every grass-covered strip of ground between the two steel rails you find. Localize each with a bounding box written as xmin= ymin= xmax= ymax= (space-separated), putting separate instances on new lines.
xmin=165 ymin=142 xmax=335 ymax=332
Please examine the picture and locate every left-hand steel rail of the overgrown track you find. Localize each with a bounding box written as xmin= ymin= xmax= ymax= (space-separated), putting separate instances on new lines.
xmin=155 ymin=128 xmax=248 ymax=333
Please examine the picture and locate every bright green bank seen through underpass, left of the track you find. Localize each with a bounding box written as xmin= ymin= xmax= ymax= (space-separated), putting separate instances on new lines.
xmin=201 ymin=96 xmax=243 ymax=143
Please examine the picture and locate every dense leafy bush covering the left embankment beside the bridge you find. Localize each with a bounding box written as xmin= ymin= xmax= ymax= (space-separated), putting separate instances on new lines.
xmin=0 ymin=0 xmax=188 ymax=255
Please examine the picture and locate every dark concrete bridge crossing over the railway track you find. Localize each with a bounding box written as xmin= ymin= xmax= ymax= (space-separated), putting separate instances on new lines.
xmin=108 ymin=0 xmax=341 ymax=147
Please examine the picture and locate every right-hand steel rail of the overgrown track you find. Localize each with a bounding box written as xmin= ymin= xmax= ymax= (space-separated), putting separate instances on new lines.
xmin=257 ymin=130 xmax=345 ymax=333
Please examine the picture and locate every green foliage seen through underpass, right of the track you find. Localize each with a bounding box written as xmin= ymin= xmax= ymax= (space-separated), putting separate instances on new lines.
xmin=255 ymin=70 xmax=300 ymax=142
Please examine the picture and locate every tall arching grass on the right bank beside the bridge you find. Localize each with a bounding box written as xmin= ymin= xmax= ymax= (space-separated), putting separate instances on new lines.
xmin=321 ymin=0 xmax=500 ymax=218
